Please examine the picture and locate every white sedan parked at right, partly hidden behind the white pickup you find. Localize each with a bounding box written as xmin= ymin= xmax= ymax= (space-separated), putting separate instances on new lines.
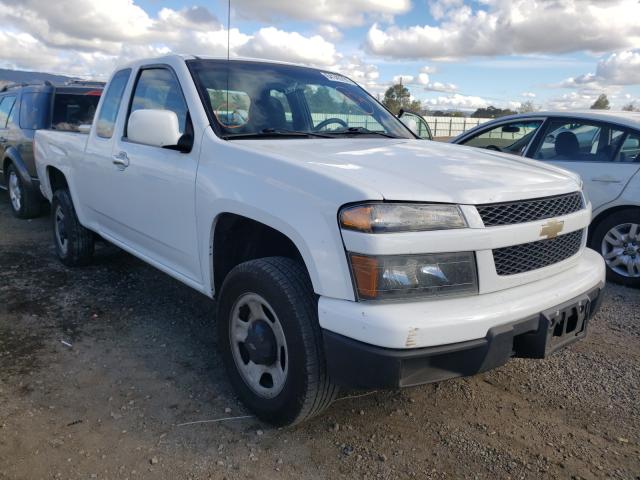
xmin=452 ymin=110 xmax=640 ymax=286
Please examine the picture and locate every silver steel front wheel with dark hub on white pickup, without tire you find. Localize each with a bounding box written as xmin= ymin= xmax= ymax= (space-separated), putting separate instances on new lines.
xmin=229 ymin=293 xmax=289 ymax=398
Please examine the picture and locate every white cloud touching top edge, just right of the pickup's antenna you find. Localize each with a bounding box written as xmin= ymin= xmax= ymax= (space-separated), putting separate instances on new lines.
xmin=232 ymin=0 xmax=411 ymax=26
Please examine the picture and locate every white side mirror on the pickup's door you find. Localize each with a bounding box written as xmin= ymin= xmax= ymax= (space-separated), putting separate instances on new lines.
xmin=127 ymin=109 xmax=182 ymax=149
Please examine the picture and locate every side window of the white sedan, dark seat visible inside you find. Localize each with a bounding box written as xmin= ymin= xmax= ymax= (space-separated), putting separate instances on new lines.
xmin=533 ymin=120 xmax=626 ymax=162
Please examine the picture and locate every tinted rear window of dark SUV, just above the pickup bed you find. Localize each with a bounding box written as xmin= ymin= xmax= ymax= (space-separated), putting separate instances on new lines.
xmin=51 ymin=90 xmax=100 ymax=132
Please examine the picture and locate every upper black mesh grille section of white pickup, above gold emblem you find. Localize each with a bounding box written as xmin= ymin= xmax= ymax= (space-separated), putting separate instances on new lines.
xmin=476 ymin=192 xmax=584 ymax=227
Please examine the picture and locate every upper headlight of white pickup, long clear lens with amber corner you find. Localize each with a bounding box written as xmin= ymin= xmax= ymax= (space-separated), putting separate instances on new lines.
xmin=340 ymin=203 xmax=467 ymax=233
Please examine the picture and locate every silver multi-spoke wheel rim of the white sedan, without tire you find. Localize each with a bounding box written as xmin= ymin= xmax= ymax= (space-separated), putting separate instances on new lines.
xmin=601 ymin=223 xmax=640 ymax=278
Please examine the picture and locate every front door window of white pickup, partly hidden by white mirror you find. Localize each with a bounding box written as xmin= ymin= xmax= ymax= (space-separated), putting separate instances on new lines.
xmin=129 ymin=68 xmax=187 ymax=133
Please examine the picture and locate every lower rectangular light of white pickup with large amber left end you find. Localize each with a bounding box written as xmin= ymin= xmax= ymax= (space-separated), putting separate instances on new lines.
xmin=349 ymin=252 xmax=478 ymax=300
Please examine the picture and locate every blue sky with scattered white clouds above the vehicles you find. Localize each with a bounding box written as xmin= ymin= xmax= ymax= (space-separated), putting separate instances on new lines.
xmin=0 ymin=0 xmax=640 ymax=111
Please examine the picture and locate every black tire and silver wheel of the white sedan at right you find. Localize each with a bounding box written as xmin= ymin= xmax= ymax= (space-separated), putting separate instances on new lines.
xmin=590 ymin=209 xmax=640 ymax=287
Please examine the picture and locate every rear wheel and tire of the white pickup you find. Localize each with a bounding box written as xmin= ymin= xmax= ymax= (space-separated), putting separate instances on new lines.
xmin=51 ymin=190 xmax=94 ymax=267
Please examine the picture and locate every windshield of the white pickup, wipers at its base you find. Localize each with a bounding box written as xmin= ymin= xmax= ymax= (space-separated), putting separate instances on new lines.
xmin=188 ymin=60 xmax=415 ymax=139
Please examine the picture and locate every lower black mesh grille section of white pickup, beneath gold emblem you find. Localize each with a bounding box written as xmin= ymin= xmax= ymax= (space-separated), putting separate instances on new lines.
xmin=493 ymin=230 xmax=583 ymax=275
